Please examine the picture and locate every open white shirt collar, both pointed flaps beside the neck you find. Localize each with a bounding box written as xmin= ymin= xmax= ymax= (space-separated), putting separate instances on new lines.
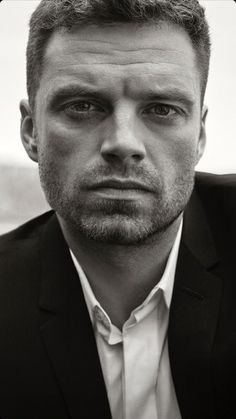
xmin=70 ymin=219 xmax=183 ymax=326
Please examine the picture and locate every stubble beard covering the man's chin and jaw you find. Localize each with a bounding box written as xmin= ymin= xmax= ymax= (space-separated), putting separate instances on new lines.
xmin=37 ymin=159 xmax=194 ymax=246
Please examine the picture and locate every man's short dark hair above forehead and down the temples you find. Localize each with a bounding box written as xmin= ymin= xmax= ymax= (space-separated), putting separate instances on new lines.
xmin=27 ymin=0 xmax=211 ymax=111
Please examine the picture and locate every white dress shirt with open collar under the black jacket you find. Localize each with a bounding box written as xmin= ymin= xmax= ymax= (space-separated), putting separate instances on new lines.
xmin=71 ymin=222 xmax=182 ymax=419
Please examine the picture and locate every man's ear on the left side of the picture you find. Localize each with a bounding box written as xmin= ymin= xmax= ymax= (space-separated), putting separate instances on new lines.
xmin=20 ymin=99 xmax=38 ymax=162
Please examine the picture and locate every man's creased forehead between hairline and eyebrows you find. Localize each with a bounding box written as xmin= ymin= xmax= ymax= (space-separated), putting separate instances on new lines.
xmin=37 ymin=23 xmax=200 ymax=104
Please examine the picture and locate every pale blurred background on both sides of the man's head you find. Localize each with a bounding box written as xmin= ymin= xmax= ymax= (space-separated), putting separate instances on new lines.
xmin=0 ymin=0 xmax=236 ymax=234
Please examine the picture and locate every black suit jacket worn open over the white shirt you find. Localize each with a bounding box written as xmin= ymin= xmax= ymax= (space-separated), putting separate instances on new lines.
xmin=0 ymin=174 xmax=236 ymax=419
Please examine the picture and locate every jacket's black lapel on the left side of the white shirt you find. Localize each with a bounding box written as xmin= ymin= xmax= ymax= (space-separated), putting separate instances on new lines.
xmin=39 ymin=216 xmax=111 ymax=419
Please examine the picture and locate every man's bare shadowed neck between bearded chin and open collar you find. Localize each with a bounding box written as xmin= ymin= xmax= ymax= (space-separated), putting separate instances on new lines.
xmin=58 ymin=217 xmax=181 ymax=328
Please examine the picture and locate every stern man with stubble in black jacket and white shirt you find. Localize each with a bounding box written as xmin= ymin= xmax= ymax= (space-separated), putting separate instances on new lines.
xmin=0 ymin=0 xmax=236 ymax=419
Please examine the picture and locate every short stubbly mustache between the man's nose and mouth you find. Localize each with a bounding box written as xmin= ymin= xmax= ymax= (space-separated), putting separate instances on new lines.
xmin=79 ymin=165 xmax=162 ymax=193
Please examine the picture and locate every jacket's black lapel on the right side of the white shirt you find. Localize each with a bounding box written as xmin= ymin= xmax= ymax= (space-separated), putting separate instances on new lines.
xmin=168 ymin=194 xmax=222 ymax=419
